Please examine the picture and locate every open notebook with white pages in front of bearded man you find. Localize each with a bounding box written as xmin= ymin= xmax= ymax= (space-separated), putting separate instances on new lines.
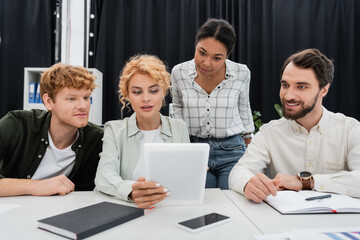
xmin=265 ymin=190 xmax=360 ymax=214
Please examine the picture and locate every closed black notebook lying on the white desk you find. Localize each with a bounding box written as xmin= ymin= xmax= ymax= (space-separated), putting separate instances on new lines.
xmin=38 ymin=202 xmax=144 ymax=239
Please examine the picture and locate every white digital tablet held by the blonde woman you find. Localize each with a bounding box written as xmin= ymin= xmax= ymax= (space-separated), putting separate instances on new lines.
xmin=144 ymin=143 xmax=210 ymax=205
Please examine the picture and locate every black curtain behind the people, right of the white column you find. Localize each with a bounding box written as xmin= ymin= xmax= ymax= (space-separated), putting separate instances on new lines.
xmin=89 ymin=0 xmax=360 ymax=122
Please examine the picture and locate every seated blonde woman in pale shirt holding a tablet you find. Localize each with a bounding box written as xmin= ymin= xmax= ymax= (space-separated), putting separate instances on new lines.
xmin=95 ymin=55 xmax=189 ymax=208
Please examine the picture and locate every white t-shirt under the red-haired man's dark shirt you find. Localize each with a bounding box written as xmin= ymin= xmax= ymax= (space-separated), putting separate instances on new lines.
xmin=31 ymin=131 xmax=79 ymax=180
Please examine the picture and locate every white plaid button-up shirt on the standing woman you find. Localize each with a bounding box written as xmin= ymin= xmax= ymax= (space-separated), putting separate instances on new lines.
xmin=171 ymin=59 xmax=254 ymax=138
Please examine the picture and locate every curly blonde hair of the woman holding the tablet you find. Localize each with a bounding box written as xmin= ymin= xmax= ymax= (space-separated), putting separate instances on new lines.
xmin=119 ymin=54 xmax=170 ymax=112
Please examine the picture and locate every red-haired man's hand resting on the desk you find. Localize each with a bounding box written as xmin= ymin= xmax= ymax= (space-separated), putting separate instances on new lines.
xmin=30 ymin=175 xmax=75 ymax=196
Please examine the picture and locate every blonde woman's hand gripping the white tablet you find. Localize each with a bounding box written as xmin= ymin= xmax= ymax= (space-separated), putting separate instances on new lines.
xmin=129 ymin=177 xmax=170 ymax=208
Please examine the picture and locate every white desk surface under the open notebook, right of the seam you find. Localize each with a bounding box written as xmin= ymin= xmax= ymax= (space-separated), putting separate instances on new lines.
xmin=223 ymin=190 xmax=360 ymax=234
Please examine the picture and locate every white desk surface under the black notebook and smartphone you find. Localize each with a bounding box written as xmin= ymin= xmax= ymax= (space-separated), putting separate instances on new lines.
xmin=0 ymin=189 xmax=261 ymax=240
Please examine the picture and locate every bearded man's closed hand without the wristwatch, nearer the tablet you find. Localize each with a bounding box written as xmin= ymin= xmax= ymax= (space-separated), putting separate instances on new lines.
xmin=244 ymin=173 xmax=276 ymax=202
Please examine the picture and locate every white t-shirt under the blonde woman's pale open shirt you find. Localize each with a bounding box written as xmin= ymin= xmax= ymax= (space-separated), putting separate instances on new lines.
xmin=132 ymin=126 xmax=164 ymax=181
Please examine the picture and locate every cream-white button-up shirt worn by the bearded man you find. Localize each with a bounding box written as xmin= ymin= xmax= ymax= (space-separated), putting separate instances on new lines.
xmin=229 ymin=108 xmax=360 ymax=197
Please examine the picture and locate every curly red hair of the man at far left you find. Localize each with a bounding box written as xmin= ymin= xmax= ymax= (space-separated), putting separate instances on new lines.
xmin=40 ymin=63 xmax=96 ymax=102
